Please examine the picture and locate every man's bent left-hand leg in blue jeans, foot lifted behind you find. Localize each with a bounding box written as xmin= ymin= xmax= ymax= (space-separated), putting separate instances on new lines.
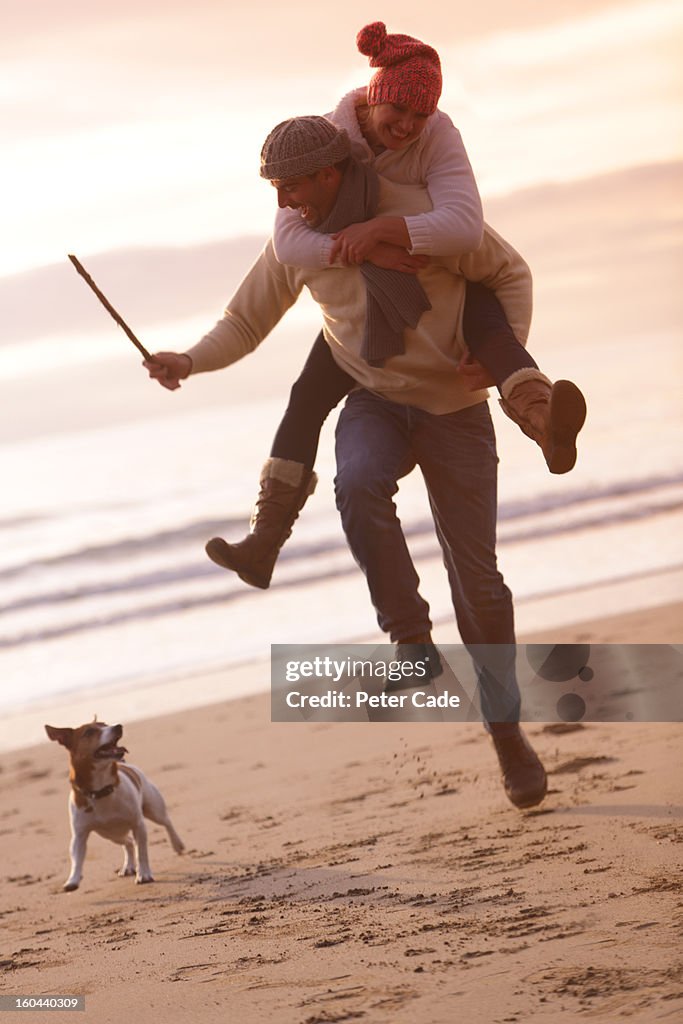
xmin=335 ymin=390 xmax=431 ymax=642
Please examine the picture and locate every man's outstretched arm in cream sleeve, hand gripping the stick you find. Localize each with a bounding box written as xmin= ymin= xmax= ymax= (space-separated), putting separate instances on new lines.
xmin=144 ymin=242 xmax=302 ymax=391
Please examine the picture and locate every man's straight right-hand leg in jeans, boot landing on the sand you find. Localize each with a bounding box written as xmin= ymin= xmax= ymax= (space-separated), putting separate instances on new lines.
xmin=413 ymin=402 xmax=547 ymax=807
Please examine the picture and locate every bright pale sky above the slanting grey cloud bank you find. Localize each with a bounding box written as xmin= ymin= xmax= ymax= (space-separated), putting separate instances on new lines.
xmin=5 ymin=0 xmax=683 ymax=278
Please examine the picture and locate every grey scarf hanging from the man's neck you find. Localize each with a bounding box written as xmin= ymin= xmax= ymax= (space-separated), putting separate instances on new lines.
xmin=315 ymin=157 xmax=431 ymax=367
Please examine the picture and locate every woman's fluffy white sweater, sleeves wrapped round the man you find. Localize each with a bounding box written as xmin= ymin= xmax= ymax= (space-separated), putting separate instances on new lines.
xmin=273 ymin=88 xmax=483 ymax=268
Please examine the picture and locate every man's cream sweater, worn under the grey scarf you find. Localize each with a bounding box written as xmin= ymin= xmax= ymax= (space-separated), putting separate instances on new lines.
xmin=186 ymin=179 xmax=531 ymax=414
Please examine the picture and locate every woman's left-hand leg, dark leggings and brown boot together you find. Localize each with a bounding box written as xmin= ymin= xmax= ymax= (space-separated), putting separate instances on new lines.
xmin=206 ymin=333 xmax=353 ymax=590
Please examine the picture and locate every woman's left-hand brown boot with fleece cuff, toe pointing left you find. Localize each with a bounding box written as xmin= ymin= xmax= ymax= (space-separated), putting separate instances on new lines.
xmin=206 ymin=459 xmax=317 ymax=590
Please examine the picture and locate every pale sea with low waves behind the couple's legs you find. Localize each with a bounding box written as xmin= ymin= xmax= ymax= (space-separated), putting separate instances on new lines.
xmin=0 ymin=319 xmax=683 ymax=729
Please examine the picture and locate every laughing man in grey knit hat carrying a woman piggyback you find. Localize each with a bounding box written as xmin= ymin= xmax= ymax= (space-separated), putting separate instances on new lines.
xmin=145 ymin=118 xmax=547 ymax=807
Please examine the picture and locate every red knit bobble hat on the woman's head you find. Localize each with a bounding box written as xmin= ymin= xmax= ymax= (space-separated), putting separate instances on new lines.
xmin=355 ymin=22 xmax=441 ymax=115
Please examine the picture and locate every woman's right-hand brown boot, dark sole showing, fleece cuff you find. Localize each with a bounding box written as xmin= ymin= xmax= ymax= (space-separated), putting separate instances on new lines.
xmin=500 ymin=367 xmax=586 ymax=473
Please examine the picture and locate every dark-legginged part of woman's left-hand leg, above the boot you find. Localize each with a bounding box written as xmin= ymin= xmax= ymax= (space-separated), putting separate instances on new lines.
xmin=270 ymin=331 xmax=353 ymax=470
